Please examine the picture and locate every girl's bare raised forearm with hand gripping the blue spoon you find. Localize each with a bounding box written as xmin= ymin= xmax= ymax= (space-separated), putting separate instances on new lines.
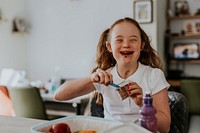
xmin=54 ymin=70 xmax=112 ymax=100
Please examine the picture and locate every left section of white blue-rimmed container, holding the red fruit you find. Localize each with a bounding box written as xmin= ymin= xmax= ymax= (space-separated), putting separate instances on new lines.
xmin=31 ymin=116 xmax=122 ymax=133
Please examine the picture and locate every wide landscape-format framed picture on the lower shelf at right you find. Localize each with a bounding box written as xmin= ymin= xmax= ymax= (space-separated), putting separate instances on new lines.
xmin=173 ymin=43 xmax=200 ymax=60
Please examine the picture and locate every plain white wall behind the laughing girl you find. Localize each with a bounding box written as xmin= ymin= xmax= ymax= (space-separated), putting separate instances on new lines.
xmin=0 ymin=0 xmax=165 ymax=81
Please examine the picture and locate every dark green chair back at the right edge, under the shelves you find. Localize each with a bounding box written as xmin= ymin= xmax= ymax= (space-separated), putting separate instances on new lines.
xmin=180 ymin=79 xmax=200 ymax=115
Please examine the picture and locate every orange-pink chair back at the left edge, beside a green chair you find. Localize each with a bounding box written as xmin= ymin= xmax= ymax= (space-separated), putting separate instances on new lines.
xmin=0 ymin=86 xmax=14 ymax=116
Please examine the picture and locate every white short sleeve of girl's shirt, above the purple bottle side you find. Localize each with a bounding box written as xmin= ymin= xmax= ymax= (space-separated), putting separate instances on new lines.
xmin=149 ymin=68 xmax=170 ymax=95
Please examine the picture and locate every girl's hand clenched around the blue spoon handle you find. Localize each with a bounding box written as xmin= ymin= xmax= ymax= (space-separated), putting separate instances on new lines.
xmin=91 ymin=69 xmax=113 ymax=86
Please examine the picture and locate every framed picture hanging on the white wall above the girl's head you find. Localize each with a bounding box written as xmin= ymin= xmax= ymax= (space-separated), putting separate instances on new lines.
xmin=133 ymin=0 xmax=153 ymax=23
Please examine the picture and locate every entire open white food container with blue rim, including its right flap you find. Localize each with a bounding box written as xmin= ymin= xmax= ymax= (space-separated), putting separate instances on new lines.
xmin=31 ymin=116 xmax=149 ymax=133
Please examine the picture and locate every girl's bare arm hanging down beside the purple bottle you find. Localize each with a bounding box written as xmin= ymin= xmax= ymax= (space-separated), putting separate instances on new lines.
xmin=153 ymin=89 xmax=171 ymax=133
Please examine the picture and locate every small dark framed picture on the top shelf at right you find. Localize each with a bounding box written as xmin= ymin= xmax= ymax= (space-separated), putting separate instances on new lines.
xmin=175 ymin=0 xmax=190 ymax=16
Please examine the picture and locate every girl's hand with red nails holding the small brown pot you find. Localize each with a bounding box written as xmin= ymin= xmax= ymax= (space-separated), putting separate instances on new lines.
xmin=126 ymin=82 xmax=143 ymax=107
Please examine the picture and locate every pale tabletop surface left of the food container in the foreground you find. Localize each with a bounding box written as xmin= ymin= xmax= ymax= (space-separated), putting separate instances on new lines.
xmin=0 ymin=115 xmax=44 ymax=133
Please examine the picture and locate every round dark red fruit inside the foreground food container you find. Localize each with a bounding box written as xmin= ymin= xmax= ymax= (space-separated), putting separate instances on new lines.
xmin=52 ymin=123 xmax=71 ymax=133
